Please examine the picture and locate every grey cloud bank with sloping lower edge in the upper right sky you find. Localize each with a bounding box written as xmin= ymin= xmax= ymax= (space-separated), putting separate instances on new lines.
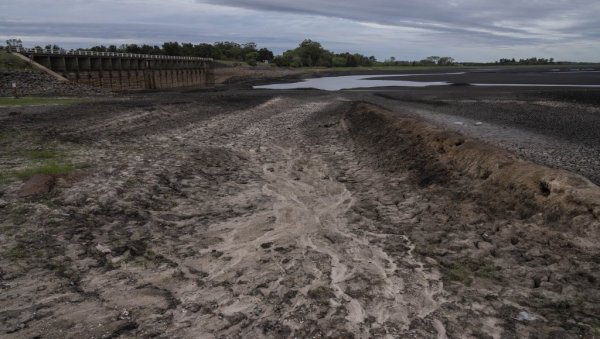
xmin=199 ymin=0 xmax=600 ymax=43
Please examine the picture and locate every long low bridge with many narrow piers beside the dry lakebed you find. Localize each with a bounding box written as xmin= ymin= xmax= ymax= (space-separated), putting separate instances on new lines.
xmin=10 ymin=47 xmax=214 ymax=91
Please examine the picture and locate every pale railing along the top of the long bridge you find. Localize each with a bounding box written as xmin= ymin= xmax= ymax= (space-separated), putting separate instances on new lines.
xmin=10 ymin=47 xmax=213 ymax=61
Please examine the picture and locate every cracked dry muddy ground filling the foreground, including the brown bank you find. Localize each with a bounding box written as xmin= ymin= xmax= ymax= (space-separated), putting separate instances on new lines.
xmin=0 ymin=90 xmax=600 ymax=338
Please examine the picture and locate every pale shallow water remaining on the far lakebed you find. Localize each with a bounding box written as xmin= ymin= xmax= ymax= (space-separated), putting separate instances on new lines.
xmin=254 ymin=72 xmax=600 ymax=91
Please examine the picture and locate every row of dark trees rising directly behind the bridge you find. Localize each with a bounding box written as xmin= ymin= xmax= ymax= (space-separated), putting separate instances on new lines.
xmin=88 ymin=41 xmax=274 ymax=65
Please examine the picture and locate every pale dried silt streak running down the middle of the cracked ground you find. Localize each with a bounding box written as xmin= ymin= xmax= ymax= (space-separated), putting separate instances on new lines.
xmin=161 ymin=98 xmax=450 ymax=338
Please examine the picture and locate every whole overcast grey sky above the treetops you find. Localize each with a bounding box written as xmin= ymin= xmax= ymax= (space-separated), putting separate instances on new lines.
xmin=0 ymin=0 xmax=600 ymax=62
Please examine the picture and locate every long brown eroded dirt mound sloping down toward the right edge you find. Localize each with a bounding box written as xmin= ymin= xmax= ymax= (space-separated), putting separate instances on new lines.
xmin=347 ymin=103 xmax=600 ymax=239
